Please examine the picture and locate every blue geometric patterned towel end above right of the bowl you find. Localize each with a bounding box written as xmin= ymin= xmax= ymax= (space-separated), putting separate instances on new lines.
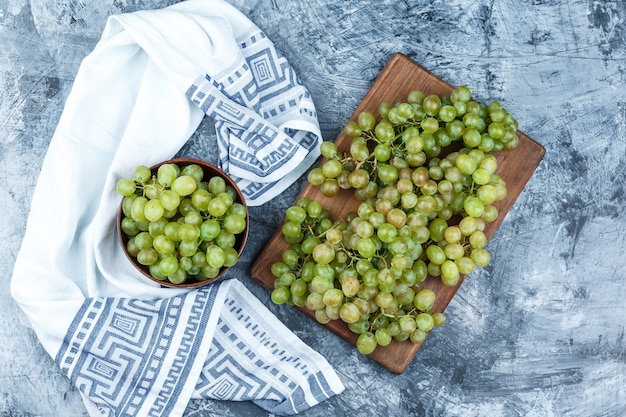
xmin=186 ymin=24 xmax=321 ymax=200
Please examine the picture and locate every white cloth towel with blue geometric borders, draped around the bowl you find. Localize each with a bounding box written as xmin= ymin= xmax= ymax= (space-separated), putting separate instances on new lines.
xmin=11 ymin=0 xmax=344 ymax=416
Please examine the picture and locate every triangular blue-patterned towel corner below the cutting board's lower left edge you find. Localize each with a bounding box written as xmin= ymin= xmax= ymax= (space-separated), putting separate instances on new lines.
xmin=194 ymin=293 xmax=333 ymax=415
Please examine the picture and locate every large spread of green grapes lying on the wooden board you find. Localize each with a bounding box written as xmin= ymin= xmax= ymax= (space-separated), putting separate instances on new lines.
xmin=272 ymin=86 xmax=519 ymax=354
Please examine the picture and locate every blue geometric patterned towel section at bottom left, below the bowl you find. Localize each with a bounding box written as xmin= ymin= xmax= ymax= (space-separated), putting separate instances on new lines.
xmin=55 ymin=285 xmax=219 ymax=417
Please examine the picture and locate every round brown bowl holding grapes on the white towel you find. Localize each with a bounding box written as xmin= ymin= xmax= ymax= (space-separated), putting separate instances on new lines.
xmin=117 ymin=158 xmax=250 ymax=288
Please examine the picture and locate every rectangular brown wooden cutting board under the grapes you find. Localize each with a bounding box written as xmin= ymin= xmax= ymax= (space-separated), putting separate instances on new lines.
xmin=250 ymin=53 xmax=545 ymax=373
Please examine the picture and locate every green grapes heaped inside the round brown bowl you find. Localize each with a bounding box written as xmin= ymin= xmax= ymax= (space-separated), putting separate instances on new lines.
xmin=116 ymin=163 xmax=247 ymax=284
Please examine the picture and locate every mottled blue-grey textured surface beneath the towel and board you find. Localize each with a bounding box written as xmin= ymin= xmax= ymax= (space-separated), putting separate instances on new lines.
xmin=0 ymin=0 xmax=626 ymax=417
